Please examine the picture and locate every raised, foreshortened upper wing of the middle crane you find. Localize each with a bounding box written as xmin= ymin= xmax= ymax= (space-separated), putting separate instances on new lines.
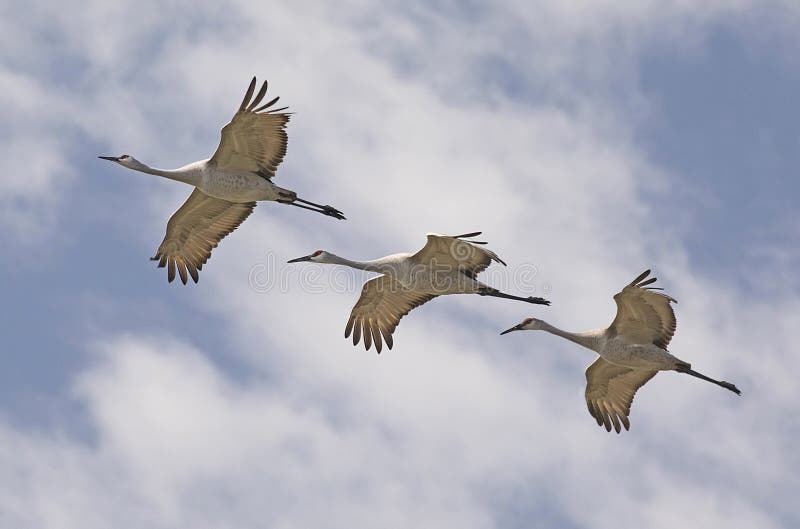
xmin=411 ymin=231 xmax=506 ymax=279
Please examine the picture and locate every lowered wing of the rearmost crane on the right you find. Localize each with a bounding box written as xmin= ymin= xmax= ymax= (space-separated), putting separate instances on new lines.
xmin=586 ymin=357 xmax=658 ymax=433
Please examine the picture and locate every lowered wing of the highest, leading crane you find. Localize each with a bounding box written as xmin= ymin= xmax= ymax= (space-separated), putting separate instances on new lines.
xmin=151 ymin=188 xmax=256 ymax=285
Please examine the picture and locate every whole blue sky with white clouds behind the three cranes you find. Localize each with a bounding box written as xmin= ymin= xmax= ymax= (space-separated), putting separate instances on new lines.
xmin=0 ymin=0 xmax=800 ymax=529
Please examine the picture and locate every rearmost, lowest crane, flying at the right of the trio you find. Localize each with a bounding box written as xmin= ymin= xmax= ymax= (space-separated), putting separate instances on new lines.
xmin=500 ymin=270 xmax=741 ymax=433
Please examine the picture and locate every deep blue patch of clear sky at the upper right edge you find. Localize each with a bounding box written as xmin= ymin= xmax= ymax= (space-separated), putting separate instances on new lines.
xmin=641 ymin=26 xmax=800 ymax=280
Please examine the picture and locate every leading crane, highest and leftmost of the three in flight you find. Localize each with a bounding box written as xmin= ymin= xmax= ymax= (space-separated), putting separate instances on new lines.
xmin=100 ymin=77 xmax=344 ymax=285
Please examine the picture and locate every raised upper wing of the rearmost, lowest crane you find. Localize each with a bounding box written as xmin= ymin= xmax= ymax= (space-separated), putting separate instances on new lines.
xmin=609 ymin=270 xmax=677 ymax=349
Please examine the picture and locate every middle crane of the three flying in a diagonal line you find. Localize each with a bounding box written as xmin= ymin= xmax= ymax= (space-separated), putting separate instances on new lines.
xmin=289 ymin=232 xmax=550 ymax=354
